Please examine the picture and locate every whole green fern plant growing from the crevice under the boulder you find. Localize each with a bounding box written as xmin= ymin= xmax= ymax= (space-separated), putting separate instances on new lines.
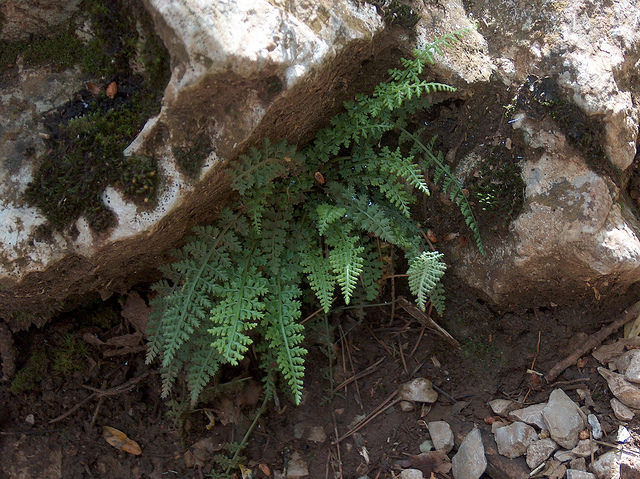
xmin=147 ymin=31 xmax=482 ymax=403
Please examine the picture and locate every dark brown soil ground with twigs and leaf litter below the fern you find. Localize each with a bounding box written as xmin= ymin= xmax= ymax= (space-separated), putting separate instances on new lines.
xmin=0 ymin=280 xmax=638 ymax=479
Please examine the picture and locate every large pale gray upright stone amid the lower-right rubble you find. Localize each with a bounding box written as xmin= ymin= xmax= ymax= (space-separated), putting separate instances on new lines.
xmin=542 ymin=389 xmax=585 ymax=449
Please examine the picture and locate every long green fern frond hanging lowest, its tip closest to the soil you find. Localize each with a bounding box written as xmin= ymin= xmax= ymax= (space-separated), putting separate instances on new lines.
xmin=265 ymin=277 xmax=307 ymax=405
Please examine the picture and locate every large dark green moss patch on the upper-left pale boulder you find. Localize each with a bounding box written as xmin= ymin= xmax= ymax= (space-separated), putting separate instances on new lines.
xmin=17 ymin=0 xmax=169 ymax=230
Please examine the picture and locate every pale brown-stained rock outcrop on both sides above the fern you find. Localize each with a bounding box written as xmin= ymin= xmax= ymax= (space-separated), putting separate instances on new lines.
xmin=0 ymin=0 xmax=640 ymax=325
